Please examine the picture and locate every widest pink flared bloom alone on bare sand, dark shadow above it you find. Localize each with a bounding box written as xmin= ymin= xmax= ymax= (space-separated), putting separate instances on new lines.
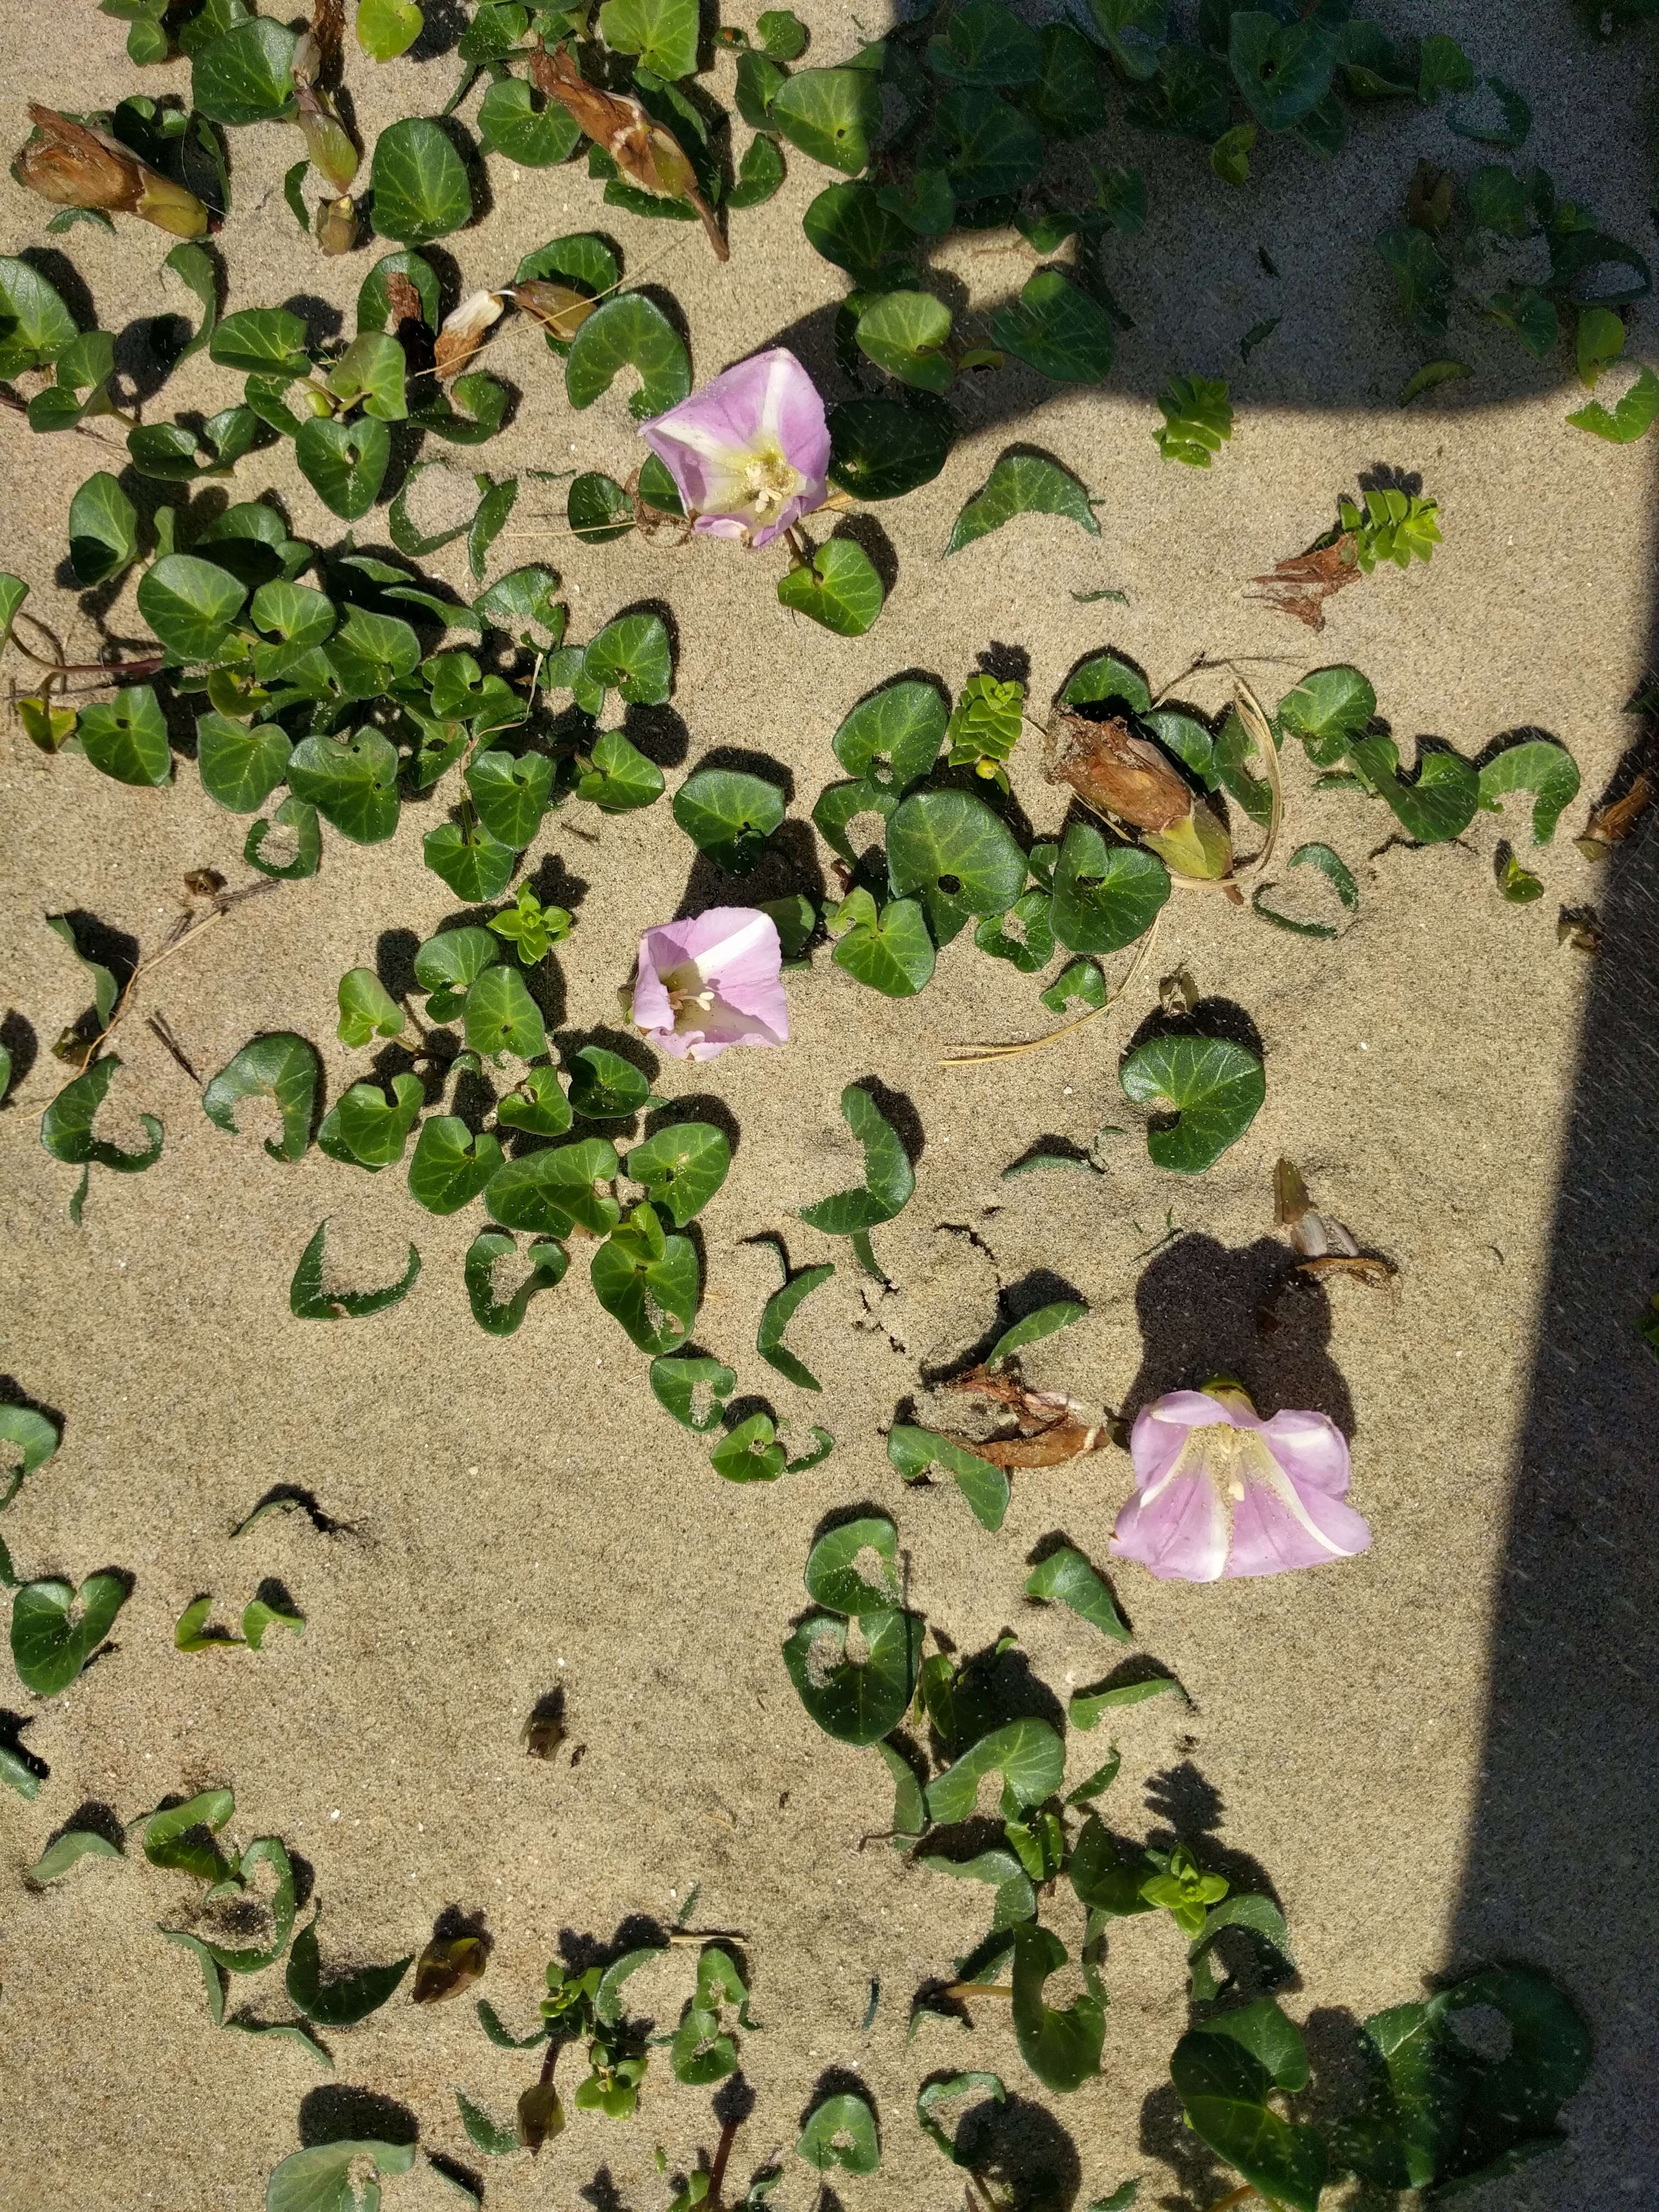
xmin=1110 ymin=1380 xmax=1372 ymax=1582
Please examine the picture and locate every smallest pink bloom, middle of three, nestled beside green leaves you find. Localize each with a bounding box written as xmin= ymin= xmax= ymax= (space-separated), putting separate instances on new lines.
xmin=633 ymin=907 xmax=789 ymax=1059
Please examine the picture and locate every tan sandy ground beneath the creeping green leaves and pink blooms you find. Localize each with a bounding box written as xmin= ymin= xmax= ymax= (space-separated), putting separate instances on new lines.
xmin=0 ymin=0 xmax=1659 ymax=2212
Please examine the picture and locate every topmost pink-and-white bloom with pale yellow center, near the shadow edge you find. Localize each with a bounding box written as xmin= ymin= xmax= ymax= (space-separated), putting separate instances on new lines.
xmin=639 ymin=345 xmax=830 ymax=546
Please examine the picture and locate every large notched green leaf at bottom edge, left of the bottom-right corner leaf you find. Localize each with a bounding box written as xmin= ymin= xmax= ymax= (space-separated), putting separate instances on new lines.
xmin=1170 ymin=1997 xmax=1325 ymax=2212
